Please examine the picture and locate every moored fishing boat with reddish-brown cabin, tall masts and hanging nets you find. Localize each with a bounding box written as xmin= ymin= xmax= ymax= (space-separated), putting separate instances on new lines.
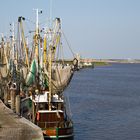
xmin=0 ymin=9 xmax=78 ymax=140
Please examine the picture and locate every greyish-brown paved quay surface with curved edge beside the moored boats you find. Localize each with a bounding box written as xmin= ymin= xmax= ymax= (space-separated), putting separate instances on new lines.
xmin=0 ymin=100 xmax=44 ymax=140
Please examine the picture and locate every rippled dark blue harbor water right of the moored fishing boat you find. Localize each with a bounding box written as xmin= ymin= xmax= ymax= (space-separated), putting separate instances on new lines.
xmin=65 ymin=64 xmax=140 ymax=140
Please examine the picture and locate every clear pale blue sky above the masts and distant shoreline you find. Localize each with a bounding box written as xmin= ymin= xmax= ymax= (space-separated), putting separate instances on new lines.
xmin=0 ymin=0 xmax=140 ymax=59
